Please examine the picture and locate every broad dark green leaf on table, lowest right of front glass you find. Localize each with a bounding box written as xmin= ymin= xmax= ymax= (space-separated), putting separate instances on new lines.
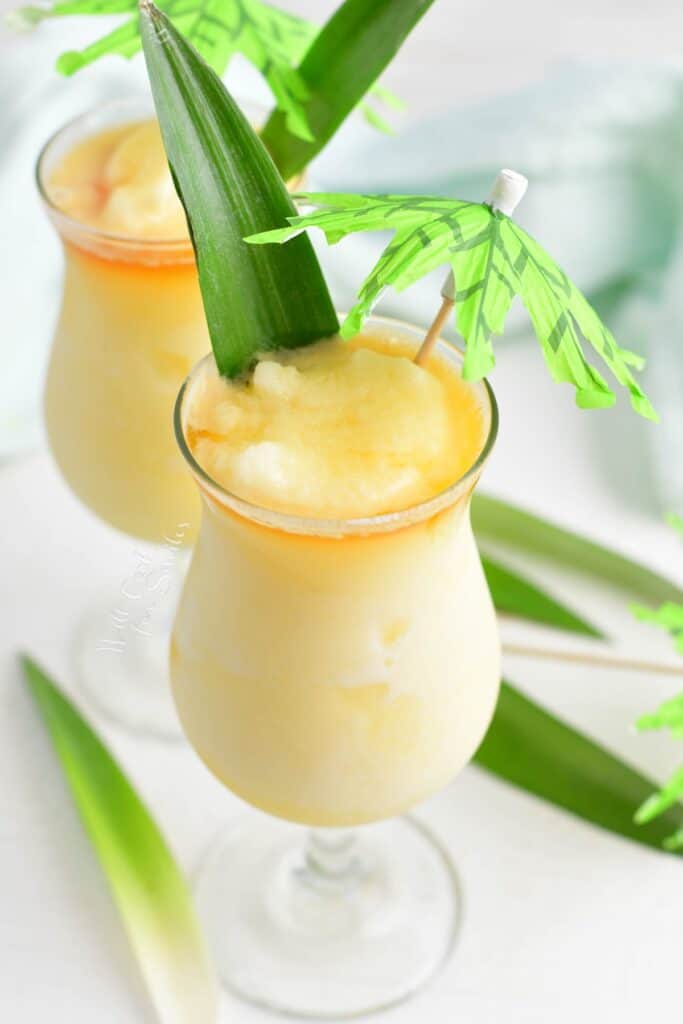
xmin=474 ymin=682 xmax=683 ymax=852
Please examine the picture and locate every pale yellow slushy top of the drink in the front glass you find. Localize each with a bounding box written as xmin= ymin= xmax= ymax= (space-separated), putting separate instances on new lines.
xmin=187 ymin=335 xmax=483 ymax=519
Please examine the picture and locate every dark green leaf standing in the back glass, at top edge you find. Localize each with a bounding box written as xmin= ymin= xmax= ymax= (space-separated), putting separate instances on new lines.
xmin=262 ymin=0 xmax=433 ymax=180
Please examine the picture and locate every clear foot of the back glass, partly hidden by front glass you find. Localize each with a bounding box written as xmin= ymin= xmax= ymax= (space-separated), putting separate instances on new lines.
xmin=76 ymin=601 xmax=182 ymax=741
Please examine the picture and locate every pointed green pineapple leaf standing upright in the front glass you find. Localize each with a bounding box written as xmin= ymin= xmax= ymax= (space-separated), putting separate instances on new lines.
xmin=140 ymin=3 xmax=339 ymax=377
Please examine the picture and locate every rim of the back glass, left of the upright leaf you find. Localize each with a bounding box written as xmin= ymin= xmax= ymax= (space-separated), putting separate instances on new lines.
xmin=34 ymin=93 xmax=197 ymax=253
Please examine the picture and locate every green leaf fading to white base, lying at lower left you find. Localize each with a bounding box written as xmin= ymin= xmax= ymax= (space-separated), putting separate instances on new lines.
xmin=20 ymin=655 xmax=218 ymax=1024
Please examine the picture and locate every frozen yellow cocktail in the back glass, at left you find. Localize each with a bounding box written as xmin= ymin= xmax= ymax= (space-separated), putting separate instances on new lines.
xmin=38 ymin=103 xmax=204 ymax=542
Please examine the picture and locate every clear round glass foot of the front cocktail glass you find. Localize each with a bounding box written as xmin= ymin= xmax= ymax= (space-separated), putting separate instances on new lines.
xmin=196 ymin=815 xmax=459 ymax=1020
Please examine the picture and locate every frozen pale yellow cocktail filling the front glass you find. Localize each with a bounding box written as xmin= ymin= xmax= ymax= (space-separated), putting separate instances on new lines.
xmin=171 ymin=321 xmax=500 ymax=826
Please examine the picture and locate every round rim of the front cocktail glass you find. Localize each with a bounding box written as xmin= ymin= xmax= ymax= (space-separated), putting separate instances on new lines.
xmin=173 ymin=313 xmax=500 ymax=538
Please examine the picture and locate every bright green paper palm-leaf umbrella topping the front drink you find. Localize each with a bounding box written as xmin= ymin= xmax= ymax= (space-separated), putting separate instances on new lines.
xmin=247 ymin=193 xmax=656 ymax=420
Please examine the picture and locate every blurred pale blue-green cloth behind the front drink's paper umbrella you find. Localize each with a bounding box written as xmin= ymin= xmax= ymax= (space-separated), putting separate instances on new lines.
xmin=311 ymin=61 xmax=683 ymax=515
